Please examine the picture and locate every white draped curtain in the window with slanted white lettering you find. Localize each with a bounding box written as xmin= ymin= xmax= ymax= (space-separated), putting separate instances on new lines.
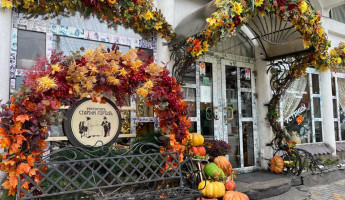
xmin=282 ymin=75 xmax=308 ymax=120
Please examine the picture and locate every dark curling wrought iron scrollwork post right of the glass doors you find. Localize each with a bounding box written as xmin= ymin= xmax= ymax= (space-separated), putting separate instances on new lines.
xmin=267 ymin=57 xmax=322 ymax=176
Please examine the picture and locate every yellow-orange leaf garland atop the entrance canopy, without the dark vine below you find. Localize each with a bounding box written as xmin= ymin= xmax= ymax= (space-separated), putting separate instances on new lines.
xmin=182 ymin=0 xmax=330 ymax=76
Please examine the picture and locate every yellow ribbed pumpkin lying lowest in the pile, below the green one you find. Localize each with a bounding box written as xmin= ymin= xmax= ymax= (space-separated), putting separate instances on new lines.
xmin=198 ymin=181 xmax=225 ymax=198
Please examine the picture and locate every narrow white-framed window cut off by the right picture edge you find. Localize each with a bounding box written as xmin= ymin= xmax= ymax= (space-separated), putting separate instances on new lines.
xmin=332 ymin=73 xmax=345 ymax=141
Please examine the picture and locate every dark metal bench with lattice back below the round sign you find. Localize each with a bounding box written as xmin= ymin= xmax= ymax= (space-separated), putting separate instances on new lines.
xmin=17 ymin=144 xmax=202 ymax=200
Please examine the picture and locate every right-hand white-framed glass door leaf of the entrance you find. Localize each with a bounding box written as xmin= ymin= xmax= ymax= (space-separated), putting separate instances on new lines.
xmin=222 ymin=60 xmax=257 ymax=168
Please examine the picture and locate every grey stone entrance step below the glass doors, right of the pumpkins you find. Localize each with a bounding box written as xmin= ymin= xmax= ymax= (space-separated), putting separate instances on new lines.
xmin=235 ymin=171 xmax=291 ymax=200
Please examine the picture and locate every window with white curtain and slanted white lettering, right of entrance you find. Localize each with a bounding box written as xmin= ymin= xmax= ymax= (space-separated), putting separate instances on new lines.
xmin=281 ymin=69 xmax=323 ymax=143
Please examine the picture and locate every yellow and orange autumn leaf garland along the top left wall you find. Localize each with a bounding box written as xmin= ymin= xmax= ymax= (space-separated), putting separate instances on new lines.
xmin=1 ymin=0 xmax=174 ymax=40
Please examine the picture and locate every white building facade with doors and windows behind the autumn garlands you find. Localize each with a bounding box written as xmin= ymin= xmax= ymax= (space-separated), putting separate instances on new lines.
xmin=0 ymin=0 xmax=345 ymax=172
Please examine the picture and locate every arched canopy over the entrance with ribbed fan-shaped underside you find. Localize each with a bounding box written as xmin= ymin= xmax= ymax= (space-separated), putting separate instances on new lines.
xmin=172 ymin=0 xmax=305 ymax=60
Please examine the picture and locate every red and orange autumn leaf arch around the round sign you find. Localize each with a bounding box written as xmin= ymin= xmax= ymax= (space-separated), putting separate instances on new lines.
xmin=0 ymin=46 xmax=190 ymax=195
